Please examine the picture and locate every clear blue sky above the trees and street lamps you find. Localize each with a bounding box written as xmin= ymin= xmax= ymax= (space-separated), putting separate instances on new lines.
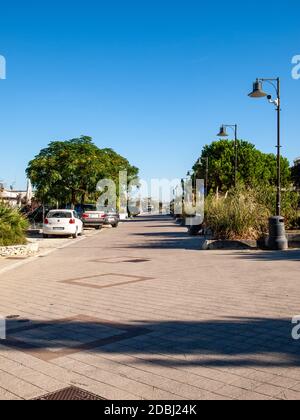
xmin=0 ymin=0 xmax=300 ymax=188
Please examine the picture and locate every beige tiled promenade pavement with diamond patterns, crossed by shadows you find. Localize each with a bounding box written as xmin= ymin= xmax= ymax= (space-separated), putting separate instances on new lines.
xmin=0 ymin=217 xmax=300 ymax=400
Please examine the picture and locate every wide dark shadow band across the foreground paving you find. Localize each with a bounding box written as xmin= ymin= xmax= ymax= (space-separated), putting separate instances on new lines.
xmin=1 ymin=318 xmax=300 ymax=368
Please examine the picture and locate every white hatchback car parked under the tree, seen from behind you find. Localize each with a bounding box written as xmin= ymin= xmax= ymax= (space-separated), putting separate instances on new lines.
xmin=43 ymin=210 xmax=83 ymax=239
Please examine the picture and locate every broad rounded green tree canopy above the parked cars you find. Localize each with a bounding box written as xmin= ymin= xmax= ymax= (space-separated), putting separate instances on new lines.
xmin=26 ymin=136 xmax=139 ymax=204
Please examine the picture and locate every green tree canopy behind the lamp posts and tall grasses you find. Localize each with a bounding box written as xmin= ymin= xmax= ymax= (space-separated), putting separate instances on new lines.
xmin=194 ymin=140 xmax=291 ymax=191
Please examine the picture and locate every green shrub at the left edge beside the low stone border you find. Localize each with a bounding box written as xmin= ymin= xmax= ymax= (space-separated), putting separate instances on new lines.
xmin=0 ymin=203 xmax=28 ymax=246
